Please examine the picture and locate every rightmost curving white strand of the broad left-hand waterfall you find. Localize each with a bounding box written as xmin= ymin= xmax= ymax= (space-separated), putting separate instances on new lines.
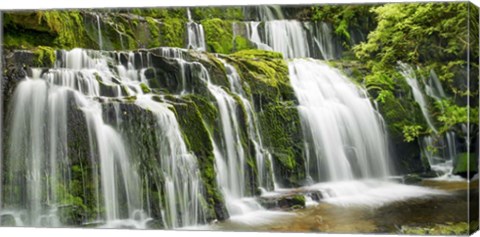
xmin=135 ymin=95 xmax=204 ymax=228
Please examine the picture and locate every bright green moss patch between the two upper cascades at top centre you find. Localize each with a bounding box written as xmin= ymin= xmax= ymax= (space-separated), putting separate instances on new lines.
xmin=202 ymin=18 xmax=233 ymax=54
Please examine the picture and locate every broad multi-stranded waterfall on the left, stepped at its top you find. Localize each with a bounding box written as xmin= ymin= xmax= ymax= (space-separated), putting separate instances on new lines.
xmin=1 ymin=49 xmax=205 ymax=228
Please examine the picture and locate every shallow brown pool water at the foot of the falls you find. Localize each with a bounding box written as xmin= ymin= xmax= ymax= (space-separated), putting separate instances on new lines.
xmin=211 ymin=180 xmax=478 ymax=234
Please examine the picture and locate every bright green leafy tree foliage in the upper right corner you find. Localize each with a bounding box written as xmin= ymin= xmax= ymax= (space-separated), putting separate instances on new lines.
xmin=354 ymin=3 xmax=478 ymax=142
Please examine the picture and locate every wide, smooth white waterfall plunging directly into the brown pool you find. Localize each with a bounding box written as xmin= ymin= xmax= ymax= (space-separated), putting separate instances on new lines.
xmin=289 ymin=59 xmax=390 ymax=181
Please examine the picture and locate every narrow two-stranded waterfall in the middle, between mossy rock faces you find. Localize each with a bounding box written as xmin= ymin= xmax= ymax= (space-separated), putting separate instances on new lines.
xmin=154 ymin=48 xmax=274 ymax=216
